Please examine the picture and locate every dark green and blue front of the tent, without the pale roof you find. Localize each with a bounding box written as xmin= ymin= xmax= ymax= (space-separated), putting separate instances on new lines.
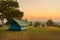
xmin=7 ymin=19 xmax=21 ymax=30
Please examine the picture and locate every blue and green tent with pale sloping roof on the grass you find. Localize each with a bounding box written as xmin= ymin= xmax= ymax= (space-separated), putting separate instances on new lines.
xmin=7 ymin=19 xmax=28 ymax=30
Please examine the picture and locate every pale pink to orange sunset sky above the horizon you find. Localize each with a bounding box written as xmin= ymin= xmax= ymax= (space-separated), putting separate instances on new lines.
xmin=18 ymin=0 xmax=60 ymax=21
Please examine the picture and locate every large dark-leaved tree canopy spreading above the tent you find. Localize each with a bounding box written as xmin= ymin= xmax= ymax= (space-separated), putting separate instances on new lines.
xmin=0 ymin=0 xmax=23 ymax=20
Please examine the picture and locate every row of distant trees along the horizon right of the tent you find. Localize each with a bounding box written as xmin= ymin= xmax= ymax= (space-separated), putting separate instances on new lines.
xmin=29 ymin=19 xmax=60 ymax=27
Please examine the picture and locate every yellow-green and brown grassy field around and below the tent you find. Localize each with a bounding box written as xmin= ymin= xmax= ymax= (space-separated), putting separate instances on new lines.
xmin=0 ymin=26 xmax=60 ymax=40
